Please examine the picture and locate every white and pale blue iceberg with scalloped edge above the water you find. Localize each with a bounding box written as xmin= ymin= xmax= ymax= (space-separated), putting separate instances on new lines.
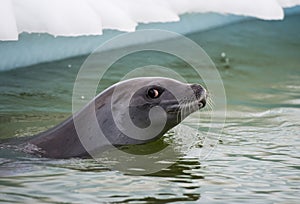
xmin=0 ymin=0 xmax=300 ymax=71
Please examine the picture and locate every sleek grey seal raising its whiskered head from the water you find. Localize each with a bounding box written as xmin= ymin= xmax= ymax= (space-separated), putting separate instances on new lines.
xmin=23 ymin=77 xmax=207 ymax=158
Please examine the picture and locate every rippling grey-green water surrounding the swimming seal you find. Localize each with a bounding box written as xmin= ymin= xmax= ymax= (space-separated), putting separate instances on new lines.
xmin=0 ymin=16 xmax=300 ymax=203
